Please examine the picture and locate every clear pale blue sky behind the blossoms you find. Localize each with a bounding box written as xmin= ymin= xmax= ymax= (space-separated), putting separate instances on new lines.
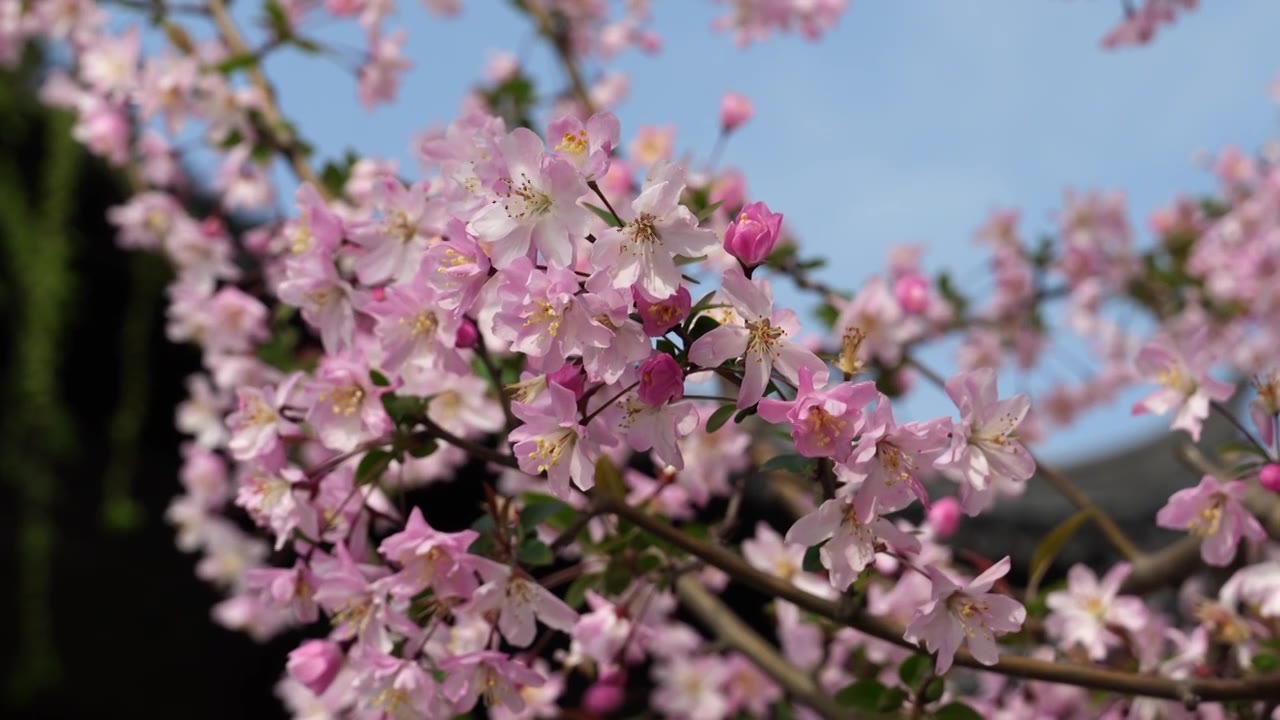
xmin=212 ymin=0 xmax=1280 ymax=459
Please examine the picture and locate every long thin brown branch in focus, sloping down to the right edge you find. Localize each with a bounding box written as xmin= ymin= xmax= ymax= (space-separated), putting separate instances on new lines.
xmin=600 ymin=496 xmax=1280 ymax=701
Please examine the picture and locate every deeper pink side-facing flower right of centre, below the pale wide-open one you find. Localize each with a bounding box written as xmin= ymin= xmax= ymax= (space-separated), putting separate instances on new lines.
xmin=759 ymin=368 xmax=879 ymax=461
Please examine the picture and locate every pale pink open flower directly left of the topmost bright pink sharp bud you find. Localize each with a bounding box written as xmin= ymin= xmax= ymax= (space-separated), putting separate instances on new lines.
xmin=591 ymin=164 xmax=716 ymax=297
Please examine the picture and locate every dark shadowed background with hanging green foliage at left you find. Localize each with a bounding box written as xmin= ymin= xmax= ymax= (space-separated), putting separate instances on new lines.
xmin=0 ymin=58 xmax=291 ymax=717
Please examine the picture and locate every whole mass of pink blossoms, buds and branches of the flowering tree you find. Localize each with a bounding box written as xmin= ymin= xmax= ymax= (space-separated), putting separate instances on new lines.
xmin=0 ymin=0 xmax=1280 ymax=720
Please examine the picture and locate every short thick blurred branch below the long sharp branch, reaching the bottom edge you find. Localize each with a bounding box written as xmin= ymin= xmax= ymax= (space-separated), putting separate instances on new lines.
xmin=676 ymin=574 xmax=849 ymax=719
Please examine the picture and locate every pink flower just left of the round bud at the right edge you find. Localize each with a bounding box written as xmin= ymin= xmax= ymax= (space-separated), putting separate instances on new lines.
xmin=1156 ymin=475 xmax=1267 ymax=568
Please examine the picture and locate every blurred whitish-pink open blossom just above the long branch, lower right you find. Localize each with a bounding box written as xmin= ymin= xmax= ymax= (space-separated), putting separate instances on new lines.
xmin=1044 ymin=562 xmax=1147 ymax=661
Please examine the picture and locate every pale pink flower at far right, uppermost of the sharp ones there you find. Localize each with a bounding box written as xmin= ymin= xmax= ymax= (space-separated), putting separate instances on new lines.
xmin=1133 ymin=341 xmax=1235 ymax=442
